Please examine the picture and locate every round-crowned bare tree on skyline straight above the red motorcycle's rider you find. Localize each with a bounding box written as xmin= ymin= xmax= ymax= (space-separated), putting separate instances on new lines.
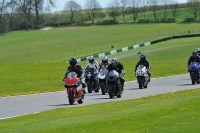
xmin=64 ymin=0 xmax=81 ymax=23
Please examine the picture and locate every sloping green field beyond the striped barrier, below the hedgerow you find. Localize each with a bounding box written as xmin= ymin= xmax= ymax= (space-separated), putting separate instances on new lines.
xmin=0 ymin=24 xmax=200 ymax=64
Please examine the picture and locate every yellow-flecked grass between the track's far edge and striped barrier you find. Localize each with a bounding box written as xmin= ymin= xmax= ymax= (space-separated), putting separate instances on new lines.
xmin=0 ymin=38 xmax=199 ymax=96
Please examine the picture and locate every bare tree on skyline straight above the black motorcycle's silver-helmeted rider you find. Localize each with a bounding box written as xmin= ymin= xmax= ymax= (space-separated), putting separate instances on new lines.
xmin=108 ymin=0 xmax=120 ymax=21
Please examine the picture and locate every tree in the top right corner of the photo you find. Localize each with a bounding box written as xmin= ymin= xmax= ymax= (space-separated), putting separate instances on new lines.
xmin=187 ymin=0 xmax=200 ymax=21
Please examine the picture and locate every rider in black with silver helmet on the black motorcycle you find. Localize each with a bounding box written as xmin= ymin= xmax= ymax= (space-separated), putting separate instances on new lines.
xmin=107 ymin=58 xmax=125 ymax=90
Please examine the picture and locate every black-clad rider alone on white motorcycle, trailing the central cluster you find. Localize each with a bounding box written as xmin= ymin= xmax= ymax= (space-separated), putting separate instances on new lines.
xmin=135 ymin=54 xmax=151 ymax=82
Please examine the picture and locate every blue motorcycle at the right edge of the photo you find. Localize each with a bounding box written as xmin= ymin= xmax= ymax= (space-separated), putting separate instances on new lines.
xmin=188 ymin=62 xmax=199 ymax=85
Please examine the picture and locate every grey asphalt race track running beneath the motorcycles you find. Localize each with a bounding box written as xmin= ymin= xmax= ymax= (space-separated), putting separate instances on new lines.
xmin=0 ymin=74 xmax=200 ymax=120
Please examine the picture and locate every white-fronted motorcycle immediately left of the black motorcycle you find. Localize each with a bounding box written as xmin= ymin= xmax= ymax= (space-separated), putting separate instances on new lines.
xmin=98 ymin=69 xmax=107 ymax=95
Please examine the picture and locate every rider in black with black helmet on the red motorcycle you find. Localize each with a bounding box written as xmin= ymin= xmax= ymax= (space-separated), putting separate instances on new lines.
xmin=63 ymin=58 xmax=86 ymax=93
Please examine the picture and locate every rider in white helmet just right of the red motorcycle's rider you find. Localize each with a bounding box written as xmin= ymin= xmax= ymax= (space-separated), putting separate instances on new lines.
xmin=85 ymin=56 xmax=99 ymax=92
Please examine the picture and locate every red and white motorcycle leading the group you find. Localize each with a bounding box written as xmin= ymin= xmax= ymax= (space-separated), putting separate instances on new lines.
xmin=64 ymin=72 xmax=84 ymax=105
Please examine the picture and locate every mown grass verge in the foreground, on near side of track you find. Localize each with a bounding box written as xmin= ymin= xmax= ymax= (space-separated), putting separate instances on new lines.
xmin=0 ymin=89 xmax=200 ymax=133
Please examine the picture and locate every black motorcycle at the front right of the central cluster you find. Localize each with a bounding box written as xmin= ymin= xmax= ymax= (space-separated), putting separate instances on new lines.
xmin=106 ymin=70 xmax=123 ymax=98
